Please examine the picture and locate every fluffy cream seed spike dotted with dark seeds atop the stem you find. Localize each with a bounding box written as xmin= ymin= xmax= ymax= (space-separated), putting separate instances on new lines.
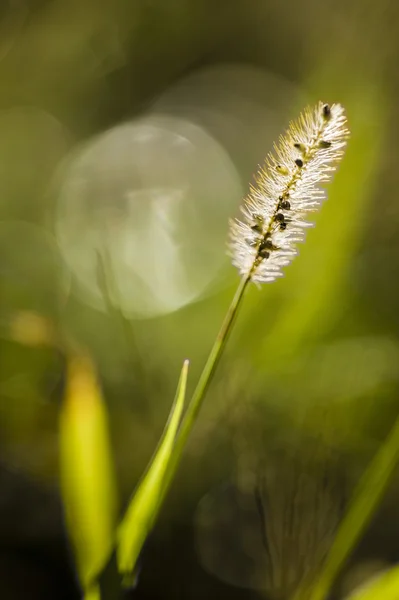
xmin=230 ymin=102 xmax=349 ymax=283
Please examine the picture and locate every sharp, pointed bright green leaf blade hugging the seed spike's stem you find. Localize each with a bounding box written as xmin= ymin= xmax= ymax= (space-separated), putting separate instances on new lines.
xmin=117 ymin=360 xmax=188 ymax=585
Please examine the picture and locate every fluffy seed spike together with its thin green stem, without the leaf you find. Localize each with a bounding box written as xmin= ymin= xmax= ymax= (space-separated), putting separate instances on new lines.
xmin=117 ymin=102 xmax=349 ymax=592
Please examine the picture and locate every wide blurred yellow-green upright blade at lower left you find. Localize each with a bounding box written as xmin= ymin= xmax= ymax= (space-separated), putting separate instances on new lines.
xmin=60 ymin=355 xmax=117 ymax=598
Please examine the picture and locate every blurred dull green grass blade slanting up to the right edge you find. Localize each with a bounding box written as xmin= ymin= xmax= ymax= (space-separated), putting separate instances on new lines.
xmin=295 ymin=418 xmax=399 ymax=600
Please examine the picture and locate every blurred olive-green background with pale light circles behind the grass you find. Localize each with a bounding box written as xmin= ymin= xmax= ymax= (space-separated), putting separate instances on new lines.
xmin=0 ymin=0 xmax=399 ymax=600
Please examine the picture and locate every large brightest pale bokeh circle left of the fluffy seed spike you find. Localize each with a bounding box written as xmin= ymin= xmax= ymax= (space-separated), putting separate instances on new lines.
xmin=56 ymin=115 xmax=242 ymax=317
